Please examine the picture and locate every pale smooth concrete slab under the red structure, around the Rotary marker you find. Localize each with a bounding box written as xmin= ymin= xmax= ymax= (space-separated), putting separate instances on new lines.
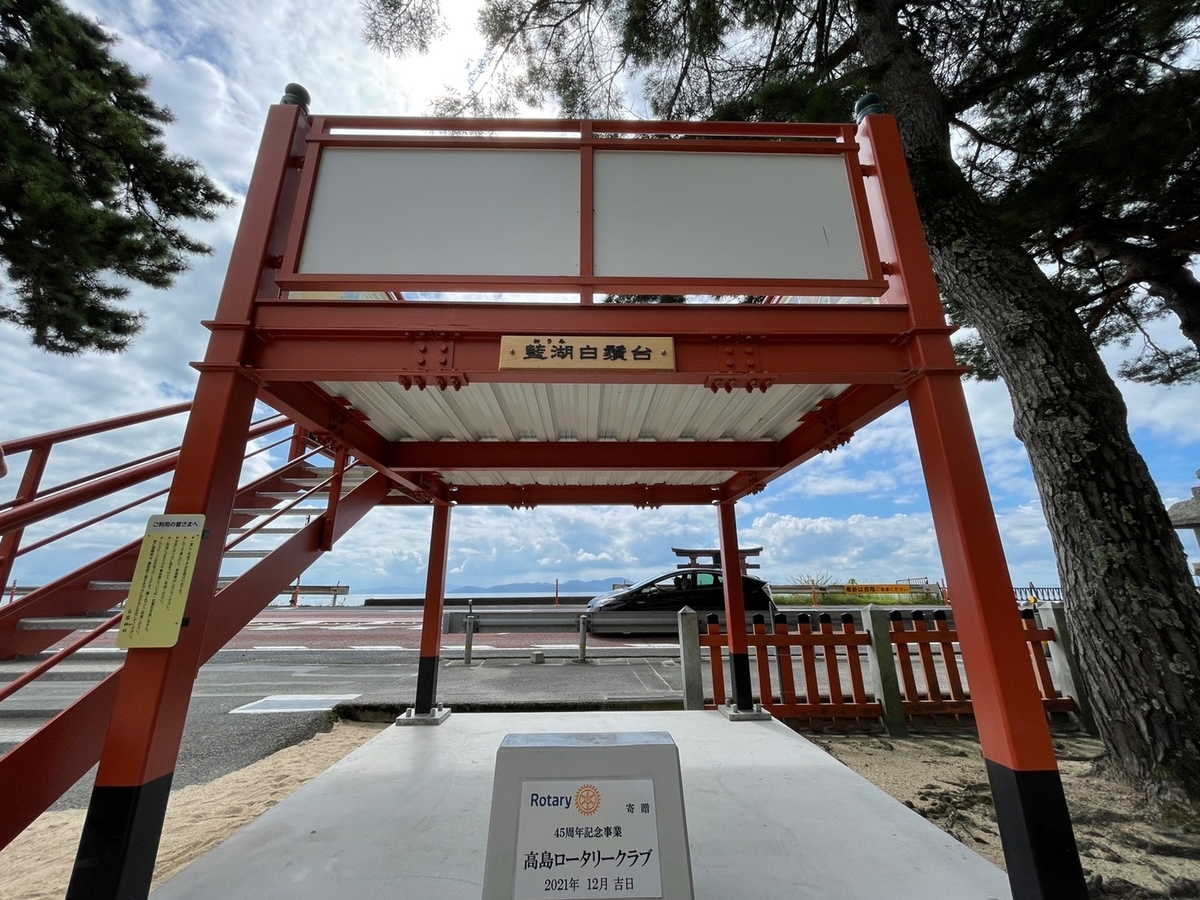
xmin=151 ymin=712 xmax=1012 ymax=900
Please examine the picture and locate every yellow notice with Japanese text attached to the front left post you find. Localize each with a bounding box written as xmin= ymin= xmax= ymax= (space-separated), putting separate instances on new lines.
xmin=116 ymin=516 xmax=204 ymax=648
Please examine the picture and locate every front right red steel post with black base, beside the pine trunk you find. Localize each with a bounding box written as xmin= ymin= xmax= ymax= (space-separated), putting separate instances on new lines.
xmin=858 ymin=115 xmax=1087 ymax=900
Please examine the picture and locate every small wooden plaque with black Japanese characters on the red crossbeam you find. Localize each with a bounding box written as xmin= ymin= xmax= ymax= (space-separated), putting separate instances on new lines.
xmin=500 ymin=335 xmax=676 ymax=372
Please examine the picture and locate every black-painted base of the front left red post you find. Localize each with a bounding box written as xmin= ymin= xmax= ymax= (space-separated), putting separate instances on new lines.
xmin=66 ymin=773 xmax=174 ymax=900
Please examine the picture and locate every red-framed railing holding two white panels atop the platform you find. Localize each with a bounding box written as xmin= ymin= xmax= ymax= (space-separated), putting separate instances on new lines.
xmin=275 ymin=116 xmax=888 ymax=302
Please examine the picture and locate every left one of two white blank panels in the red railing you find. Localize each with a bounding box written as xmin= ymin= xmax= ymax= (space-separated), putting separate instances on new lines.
xmin=299 ymin=148 xmax=580 ymax=276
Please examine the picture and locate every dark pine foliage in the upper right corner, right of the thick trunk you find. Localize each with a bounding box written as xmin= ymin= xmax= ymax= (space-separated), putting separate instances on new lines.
xmin=940 ymin=2 xmax=1200 ymax=384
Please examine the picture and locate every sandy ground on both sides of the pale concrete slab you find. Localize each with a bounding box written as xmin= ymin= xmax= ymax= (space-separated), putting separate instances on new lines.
xmin=0 ymin=722 xmax=1200 ymax=900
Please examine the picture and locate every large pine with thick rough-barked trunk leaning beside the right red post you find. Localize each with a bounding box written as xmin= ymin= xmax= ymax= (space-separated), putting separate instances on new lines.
xmin=367 ymin=0 xmax=1200 ymax=802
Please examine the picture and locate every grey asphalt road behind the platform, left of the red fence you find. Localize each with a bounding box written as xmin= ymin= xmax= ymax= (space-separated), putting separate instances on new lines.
xmin=0 ymin=607 xmax=678 ymax=809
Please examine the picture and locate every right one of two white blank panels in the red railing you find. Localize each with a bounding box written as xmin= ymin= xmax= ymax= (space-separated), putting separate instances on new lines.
xmin=594 ymin=151 xmax=868 ymax=280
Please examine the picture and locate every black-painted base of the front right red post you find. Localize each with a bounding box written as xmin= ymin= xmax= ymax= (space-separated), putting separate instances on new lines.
xmin=984 ymin=760 xmax=1087 ymax=900
